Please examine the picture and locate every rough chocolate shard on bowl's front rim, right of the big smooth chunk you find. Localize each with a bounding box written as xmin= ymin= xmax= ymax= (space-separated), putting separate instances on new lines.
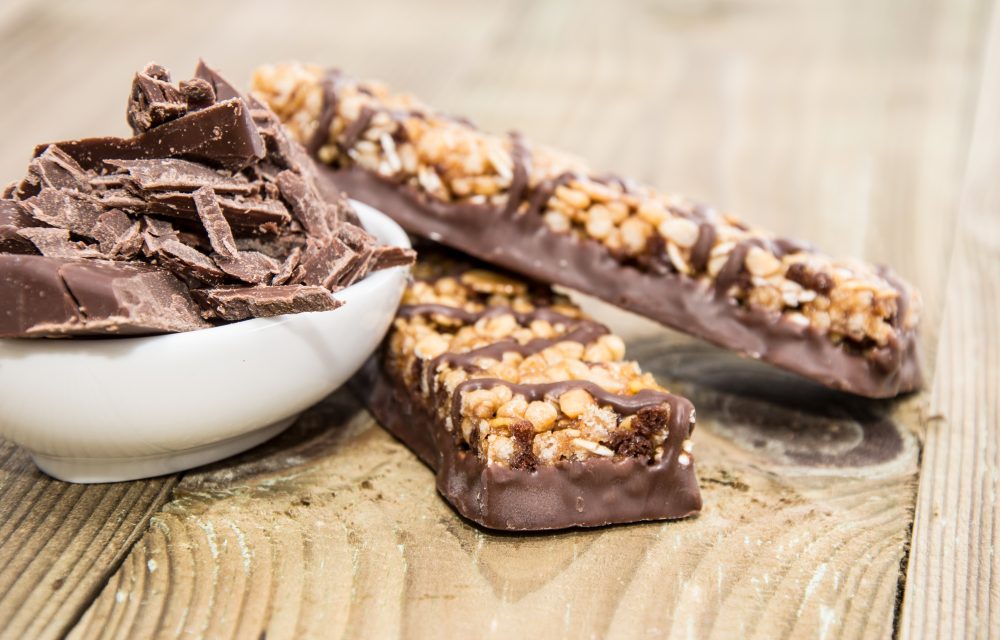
xmin=192 ymin=285 xmax=343 ymax=322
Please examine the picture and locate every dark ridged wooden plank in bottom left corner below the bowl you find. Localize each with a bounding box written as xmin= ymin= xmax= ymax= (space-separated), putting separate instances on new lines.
xmin=0 ymin=439 xmax=175 ymax=639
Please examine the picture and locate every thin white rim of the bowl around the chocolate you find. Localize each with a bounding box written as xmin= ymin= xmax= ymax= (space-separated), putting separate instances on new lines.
xmin=0 ymin=198 xmax=413 ymax=349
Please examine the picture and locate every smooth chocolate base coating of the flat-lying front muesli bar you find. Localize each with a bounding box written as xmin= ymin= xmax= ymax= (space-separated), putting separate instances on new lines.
xmin=351 ymin=358 xmax=701 ymax=531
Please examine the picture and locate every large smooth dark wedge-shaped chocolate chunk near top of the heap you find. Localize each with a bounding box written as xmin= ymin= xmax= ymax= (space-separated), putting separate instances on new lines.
xmin=42 ymin=99 xmax=264 ymax=171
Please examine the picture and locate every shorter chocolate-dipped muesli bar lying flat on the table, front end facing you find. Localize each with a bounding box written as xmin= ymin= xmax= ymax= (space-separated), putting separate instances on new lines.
xmin=355 ymin=250 xmax=701 ymax=531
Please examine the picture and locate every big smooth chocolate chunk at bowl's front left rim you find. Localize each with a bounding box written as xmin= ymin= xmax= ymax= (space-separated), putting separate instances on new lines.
xmin=0 ymin=255 xmax=209 ymax=337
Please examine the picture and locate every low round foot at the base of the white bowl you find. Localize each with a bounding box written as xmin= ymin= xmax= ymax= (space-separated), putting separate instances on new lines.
xmin=28 ymin=415 xmax=299 ymax=484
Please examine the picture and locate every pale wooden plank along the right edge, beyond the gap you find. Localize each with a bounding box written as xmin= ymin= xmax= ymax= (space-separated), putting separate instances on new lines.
xmin=901 ymin=2 xmax=1000 ymax=638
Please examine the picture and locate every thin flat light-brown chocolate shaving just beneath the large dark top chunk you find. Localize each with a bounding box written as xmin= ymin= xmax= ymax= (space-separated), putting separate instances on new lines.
xmin=106 ymin=158 xmax=257 ymax=196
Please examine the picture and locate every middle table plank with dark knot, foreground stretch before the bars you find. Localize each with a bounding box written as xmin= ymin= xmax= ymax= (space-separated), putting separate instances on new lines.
xmin=72 ymin=360 xmax=918 ymax=638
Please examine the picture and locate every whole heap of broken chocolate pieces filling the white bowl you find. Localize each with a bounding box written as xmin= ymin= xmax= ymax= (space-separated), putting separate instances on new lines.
xmin=0 ymin=64 xmax=413 ymax=337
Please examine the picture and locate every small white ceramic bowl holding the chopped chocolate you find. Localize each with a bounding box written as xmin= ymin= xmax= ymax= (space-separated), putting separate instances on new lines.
xmin=0 ymin=201 xmax=410 ymax=482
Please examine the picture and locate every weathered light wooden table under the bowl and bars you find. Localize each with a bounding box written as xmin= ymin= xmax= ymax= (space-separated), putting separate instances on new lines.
xmin=0 ymin=0 xmax=1000 ymax=638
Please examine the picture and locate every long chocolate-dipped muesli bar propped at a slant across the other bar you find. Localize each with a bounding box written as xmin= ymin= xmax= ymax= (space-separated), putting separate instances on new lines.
xmin=254 ymin=64 xmax=921 ymax=397
